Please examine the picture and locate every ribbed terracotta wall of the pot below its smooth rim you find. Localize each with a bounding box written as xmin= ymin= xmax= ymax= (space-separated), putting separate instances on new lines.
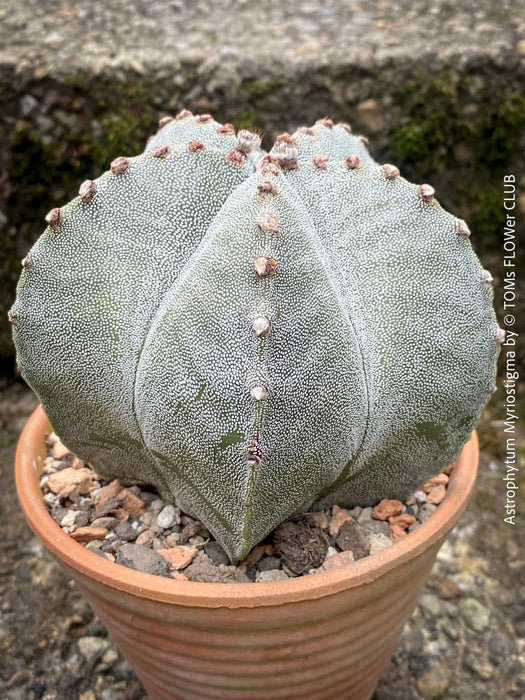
xmin=75 ymin=547 xmax=437 ymax=700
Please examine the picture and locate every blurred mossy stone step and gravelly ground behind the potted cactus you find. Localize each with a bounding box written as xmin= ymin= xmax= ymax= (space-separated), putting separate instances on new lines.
xmin=0 ymin=0 xmax=525 ymax=700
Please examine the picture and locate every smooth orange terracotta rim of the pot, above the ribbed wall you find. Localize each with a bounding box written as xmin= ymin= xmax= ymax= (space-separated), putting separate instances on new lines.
xmin=15 ymin=406 xmax=478 ymax=608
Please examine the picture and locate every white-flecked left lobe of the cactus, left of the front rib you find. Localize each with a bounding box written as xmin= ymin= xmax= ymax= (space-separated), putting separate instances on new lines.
xmin=16 ymin=144 xmax=249 ymax=524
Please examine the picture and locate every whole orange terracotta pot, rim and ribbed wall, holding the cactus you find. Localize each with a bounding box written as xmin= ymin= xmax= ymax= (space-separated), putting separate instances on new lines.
xmin=16 ymin=408 xmax=478 ymax=700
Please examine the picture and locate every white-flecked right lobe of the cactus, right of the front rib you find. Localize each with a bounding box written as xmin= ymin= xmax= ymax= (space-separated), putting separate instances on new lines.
xmin=287 ymin=157 xmax=497 ymax=507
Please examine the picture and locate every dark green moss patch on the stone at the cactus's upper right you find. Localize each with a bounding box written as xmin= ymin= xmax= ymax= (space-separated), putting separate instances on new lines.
xmin=389 ymin=71 xmax=525 ymax=253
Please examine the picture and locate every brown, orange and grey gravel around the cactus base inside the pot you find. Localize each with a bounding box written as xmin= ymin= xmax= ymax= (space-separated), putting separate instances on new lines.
xmin=40 ymin=433 xmax=453 ymax=583
